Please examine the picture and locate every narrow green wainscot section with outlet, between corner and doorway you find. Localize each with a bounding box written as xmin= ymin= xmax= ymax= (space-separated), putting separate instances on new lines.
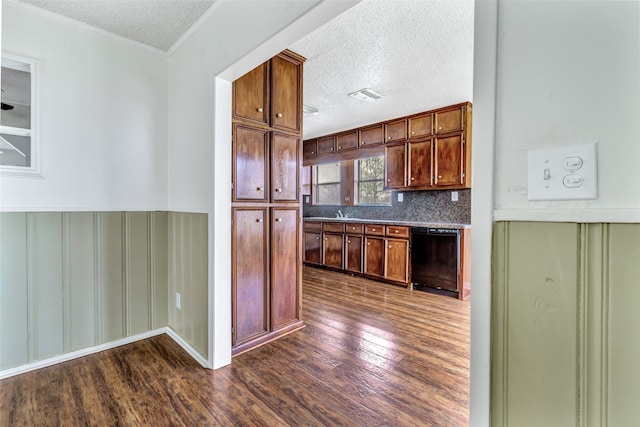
xmin=168 ymin=212 xmax=208 ymax=358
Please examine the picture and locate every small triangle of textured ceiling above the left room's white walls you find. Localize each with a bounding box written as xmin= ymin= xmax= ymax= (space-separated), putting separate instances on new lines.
xmin=20 ymin=0 xmax=213 ymax=51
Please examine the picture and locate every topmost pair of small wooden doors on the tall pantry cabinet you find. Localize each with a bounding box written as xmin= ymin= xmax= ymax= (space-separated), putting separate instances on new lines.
xmin=233 ymin=51 xmax=304 ymax=132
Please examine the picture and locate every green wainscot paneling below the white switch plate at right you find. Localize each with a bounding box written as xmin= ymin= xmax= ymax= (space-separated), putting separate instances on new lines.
xmin=491 ymin=222 xmax=640 ymax=427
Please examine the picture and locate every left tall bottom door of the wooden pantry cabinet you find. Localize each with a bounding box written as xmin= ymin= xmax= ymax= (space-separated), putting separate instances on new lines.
xmin=231 ymin=208 xmax=269 ymax=346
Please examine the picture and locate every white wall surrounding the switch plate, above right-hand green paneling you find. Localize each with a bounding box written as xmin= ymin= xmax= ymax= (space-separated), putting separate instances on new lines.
xmin=495 ymin=1 xmax=640 ymax=221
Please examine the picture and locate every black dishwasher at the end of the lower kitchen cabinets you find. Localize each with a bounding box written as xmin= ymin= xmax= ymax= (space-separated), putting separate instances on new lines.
xmin=411 ymin=227 xmax=460 ymax=295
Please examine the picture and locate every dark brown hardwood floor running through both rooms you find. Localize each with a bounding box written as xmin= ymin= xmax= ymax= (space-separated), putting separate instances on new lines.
xmin=0 ymin=267 xmax=470 ymax=426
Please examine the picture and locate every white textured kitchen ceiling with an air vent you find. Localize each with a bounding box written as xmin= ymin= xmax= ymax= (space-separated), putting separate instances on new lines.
xmin=290 ymin=0 xmax=473 ymax=138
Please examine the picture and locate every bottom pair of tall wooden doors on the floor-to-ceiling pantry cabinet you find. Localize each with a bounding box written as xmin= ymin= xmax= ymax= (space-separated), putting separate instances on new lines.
xmin=232 ymin=207 xmax=303 ymax=355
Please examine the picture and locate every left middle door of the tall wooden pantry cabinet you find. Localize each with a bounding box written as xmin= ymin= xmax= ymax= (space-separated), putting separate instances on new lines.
xmin=232 ymin=125 xmax=269 ymax=202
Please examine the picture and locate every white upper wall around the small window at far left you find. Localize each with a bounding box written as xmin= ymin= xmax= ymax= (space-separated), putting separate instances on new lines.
xmin=0 ymin=1 xmax=168 ymax=211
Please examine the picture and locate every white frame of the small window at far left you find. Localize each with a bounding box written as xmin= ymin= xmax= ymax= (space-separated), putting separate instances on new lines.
xmin=0 ymin=51 xmax=44 ymax=178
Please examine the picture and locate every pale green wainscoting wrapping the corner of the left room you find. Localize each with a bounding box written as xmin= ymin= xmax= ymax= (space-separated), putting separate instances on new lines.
xmin=0 ymin=212 xmax=207 ymax=371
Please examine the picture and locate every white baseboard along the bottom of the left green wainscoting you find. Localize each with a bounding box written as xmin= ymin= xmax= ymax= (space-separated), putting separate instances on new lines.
xmin=0 ymin=327 xmax=209 ymax=380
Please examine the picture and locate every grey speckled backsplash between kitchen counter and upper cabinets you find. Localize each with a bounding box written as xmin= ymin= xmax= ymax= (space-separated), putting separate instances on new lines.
xmin=303 ymin=190 xmax=471 ymax=224
